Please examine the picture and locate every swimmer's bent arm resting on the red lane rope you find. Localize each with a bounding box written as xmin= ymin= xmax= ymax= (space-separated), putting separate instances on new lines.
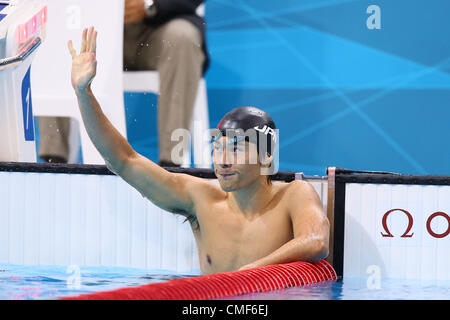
xmin=240 ymin=181 xmax=330 ymax=270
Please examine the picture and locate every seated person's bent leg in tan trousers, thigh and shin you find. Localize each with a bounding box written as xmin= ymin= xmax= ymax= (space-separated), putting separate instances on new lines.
xmin=124 ymin=19 xmax=205 ymax=165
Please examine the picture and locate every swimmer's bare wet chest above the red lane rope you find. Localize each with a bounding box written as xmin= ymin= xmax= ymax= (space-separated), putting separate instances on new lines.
xmin=196 ymin=205 xmax=293 ymax=273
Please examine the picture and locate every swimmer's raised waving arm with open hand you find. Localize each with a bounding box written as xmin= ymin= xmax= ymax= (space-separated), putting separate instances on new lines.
xmin=68 ymin=27 xmax=202 ymax=216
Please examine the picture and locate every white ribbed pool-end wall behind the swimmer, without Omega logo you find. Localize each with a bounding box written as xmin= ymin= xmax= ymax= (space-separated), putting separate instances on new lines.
xmin=0 ymin=172 xmax=310 ymax=272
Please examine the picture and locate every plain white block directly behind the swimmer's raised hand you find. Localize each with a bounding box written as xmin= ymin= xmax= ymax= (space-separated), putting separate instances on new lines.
xmin=32 ymin=0 xmax=127 ymax=164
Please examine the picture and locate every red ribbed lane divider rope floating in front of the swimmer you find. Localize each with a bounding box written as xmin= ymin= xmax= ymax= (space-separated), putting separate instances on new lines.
xmin=62 ymin=260 xmax=337 ymax=300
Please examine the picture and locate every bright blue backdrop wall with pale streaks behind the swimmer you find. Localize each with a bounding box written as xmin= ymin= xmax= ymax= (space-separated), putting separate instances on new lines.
xmin=38 ymin=0 xmax=450 ymax=175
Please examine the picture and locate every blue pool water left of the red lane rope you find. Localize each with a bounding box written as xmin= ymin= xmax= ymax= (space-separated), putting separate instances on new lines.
xmin=0 ymin=263 xmax=200 ymax=300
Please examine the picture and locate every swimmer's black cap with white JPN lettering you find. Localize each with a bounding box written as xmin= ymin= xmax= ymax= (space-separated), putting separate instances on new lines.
xmin=217 ymin=107 xmax=277 ymax=155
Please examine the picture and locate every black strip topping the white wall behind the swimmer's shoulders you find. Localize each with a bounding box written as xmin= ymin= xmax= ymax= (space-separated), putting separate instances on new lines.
xmin=0 ymin=162 xmax=295 ymax=182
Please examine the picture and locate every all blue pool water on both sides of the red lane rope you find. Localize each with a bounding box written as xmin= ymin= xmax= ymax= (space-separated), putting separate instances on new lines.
xmin=0 ymin=264 xmax=450 ymax=300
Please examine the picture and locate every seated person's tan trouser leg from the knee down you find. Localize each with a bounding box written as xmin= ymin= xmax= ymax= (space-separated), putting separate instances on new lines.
xmin=158 ymin=19 xmax=204 ymax=168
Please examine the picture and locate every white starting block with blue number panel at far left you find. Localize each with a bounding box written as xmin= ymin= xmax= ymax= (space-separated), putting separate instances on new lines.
xmin=0 ymin=0 xmax=47 ymax=162
